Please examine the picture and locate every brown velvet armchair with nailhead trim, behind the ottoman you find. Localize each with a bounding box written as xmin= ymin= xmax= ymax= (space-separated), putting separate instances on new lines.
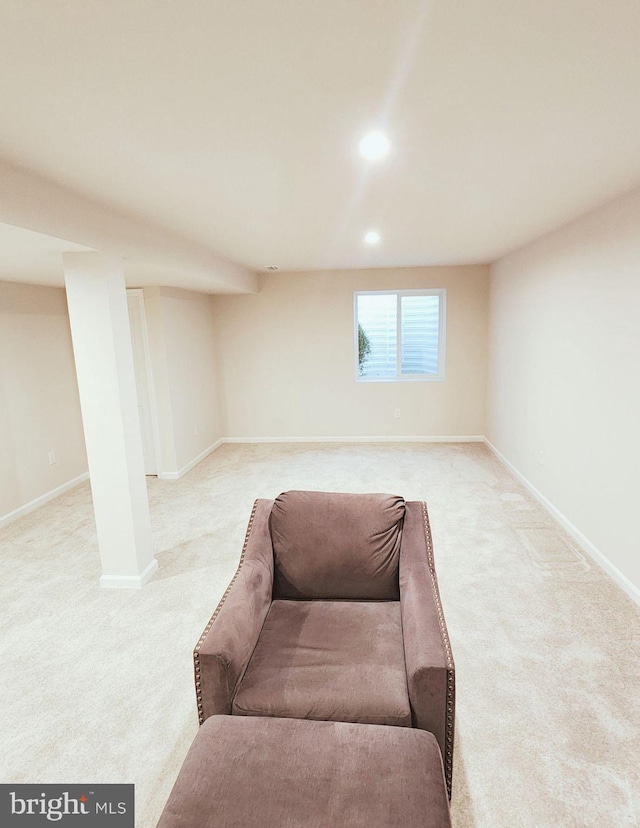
xmin=194 ymin=491 xmax=455 ymax=794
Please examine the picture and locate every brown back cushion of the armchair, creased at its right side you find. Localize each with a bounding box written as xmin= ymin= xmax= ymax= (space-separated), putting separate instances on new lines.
xmin=269 ymin=491 xmax=405 ymax=601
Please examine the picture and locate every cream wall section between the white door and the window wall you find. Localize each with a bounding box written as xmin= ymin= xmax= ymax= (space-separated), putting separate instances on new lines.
xmin=144 ymin=288 xmax=223 ymax=475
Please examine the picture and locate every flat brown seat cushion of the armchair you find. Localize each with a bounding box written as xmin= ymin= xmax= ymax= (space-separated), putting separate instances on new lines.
xmin=232 ymin=600 xmax=411 ymax=727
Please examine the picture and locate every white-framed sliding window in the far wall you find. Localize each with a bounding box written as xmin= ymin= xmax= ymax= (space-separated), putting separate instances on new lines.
xmin=354 ymin=290 xmax=446 ymax=382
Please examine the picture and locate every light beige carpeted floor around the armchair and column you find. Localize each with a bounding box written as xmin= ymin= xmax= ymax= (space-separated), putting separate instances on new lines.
xmin=0 ymin=444 xmax=640 ymax=828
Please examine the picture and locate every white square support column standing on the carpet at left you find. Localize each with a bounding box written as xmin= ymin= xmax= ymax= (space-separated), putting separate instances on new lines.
xmin=63 ymin=253 xmax=158 ymax=587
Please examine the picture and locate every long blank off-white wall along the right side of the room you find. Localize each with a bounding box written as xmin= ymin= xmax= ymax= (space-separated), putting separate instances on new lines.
xmin=488 ymin=190 xmax=640 ymax=597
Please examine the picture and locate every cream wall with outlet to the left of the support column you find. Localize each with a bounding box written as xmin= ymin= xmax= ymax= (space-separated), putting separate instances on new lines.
xmin=0 ymin=282 xmax=87 ymax=518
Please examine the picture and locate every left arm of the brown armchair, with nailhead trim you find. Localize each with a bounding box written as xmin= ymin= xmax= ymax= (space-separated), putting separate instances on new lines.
xmin=193 ymin=500 xmax=273 ymax=724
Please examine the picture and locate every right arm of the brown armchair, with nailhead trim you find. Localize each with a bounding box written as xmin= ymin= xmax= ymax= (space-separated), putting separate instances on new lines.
xmin=400 ymin=501 xmax=455 ymax=797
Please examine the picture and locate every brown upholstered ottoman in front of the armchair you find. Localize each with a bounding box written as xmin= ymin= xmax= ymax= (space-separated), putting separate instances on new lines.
xmin=158 ymin=716 xmax=451 ymax=828
